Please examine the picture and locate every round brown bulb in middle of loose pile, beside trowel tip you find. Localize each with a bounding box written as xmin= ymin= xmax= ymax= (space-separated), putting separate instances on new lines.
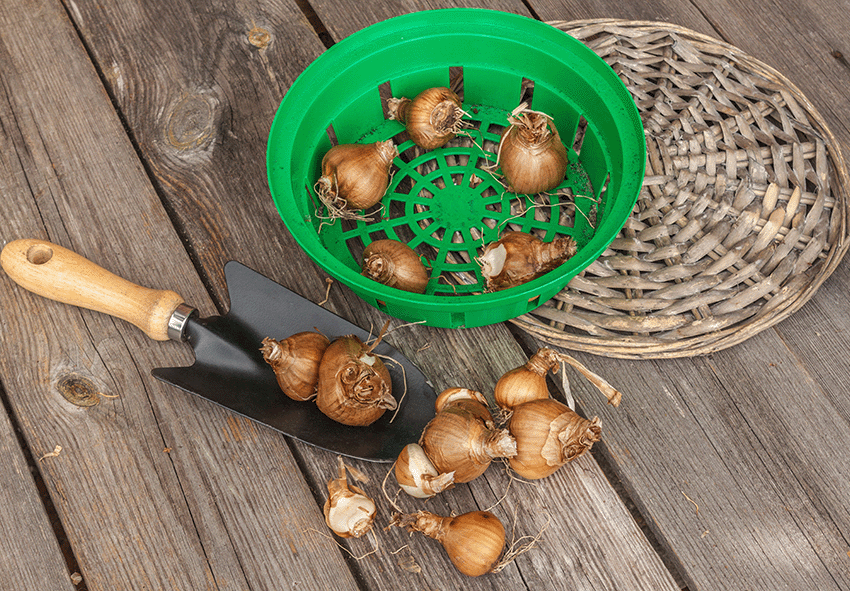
xmin=419 ymin=389 xmax=516 ymax=482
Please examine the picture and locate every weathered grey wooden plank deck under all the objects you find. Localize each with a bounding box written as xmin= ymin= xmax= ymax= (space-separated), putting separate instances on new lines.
xmin=0 ymin=0 xmax=850 ymax=591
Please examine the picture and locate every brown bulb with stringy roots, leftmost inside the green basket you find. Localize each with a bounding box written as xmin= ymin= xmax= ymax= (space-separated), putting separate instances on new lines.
xmin=316 ymin=140 xmax=398 ymax=219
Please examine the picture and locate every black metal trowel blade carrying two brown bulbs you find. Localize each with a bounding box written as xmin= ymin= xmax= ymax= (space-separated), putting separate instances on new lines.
xmin=152 ymin=261 xmax=436 ymax=462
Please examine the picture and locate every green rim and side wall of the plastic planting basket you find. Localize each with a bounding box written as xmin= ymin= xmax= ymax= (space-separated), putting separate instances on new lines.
xmin=267 ymin=8 xmax=646 ymax=328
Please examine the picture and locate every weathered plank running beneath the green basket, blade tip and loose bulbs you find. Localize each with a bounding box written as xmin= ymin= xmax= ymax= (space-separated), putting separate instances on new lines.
xmin=56 ymin=2 xmax=674 ymax=590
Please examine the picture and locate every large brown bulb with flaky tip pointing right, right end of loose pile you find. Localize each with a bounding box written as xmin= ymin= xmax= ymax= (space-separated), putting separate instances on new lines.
xmin=508 ymin=398 xmax=602 ymax=480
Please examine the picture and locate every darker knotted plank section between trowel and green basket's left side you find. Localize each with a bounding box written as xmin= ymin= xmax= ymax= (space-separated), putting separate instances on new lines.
xmin=65 ymin=0 xmax=324 ymax=302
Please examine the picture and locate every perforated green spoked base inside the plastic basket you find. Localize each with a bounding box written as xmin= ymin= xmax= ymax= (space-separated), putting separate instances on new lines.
xmin=316 ymin=104 xmax=605 ymax=297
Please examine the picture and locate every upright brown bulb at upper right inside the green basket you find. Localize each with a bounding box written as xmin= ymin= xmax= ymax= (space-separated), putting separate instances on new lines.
xmin=497 ymin=103 xmax=567 ymax=195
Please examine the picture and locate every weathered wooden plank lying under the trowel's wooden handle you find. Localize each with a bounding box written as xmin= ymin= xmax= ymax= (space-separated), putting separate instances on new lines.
xmin=0 ymin=1 xmax=357 ymax=590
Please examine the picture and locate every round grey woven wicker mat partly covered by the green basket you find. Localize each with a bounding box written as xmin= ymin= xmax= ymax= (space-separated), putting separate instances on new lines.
xmin=512 ymin=20 xmax=850 ymax=359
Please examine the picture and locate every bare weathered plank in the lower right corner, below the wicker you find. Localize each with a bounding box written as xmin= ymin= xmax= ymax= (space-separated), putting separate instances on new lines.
xmin=544 ymin=333 xmax=850 ymax=589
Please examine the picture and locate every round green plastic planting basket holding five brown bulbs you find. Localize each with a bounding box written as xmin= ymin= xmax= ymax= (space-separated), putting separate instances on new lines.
xmin=267 ymin=8 xmax=646 ymax=328
